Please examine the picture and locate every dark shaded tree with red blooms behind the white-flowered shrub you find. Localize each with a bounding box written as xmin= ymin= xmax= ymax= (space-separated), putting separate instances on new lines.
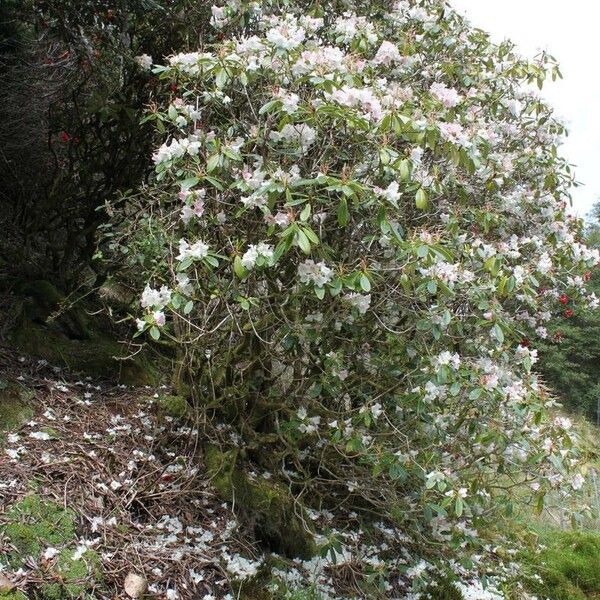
xmin=0 ymin=0 xmax=210 ymax=291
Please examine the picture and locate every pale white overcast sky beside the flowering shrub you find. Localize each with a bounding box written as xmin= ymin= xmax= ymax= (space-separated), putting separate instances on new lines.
xmin=450 ymin=0 xmax=600 ymax=217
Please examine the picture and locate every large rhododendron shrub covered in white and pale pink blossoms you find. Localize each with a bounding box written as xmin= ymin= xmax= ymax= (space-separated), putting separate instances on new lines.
xmin=123 ymin=0 xmax=598 ymax=597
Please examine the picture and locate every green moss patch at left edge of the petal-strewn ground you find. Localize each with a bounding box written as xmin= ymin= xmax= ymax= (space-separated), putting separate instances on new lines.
xmin=2 ymin=495 xmax=75 ymax=568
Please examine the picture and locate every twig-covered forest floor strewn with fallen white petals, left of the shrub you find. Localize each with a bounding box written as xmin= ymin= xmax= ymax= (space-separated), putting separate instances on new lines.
xmin=0 ymin=349 xmax=254 ymax=600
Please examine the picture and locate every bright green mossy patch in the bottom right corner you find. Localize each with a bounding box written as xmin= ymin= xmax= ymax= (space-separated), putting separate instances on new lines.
xmin=524 ymin=531 xmax=600 ymax=600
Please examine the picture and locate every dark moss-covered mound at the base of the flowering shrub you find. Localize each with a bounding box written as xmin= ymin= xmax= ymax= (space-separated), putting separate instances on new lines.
xmin=205 ymin=446 xmax=316 ymax=559
